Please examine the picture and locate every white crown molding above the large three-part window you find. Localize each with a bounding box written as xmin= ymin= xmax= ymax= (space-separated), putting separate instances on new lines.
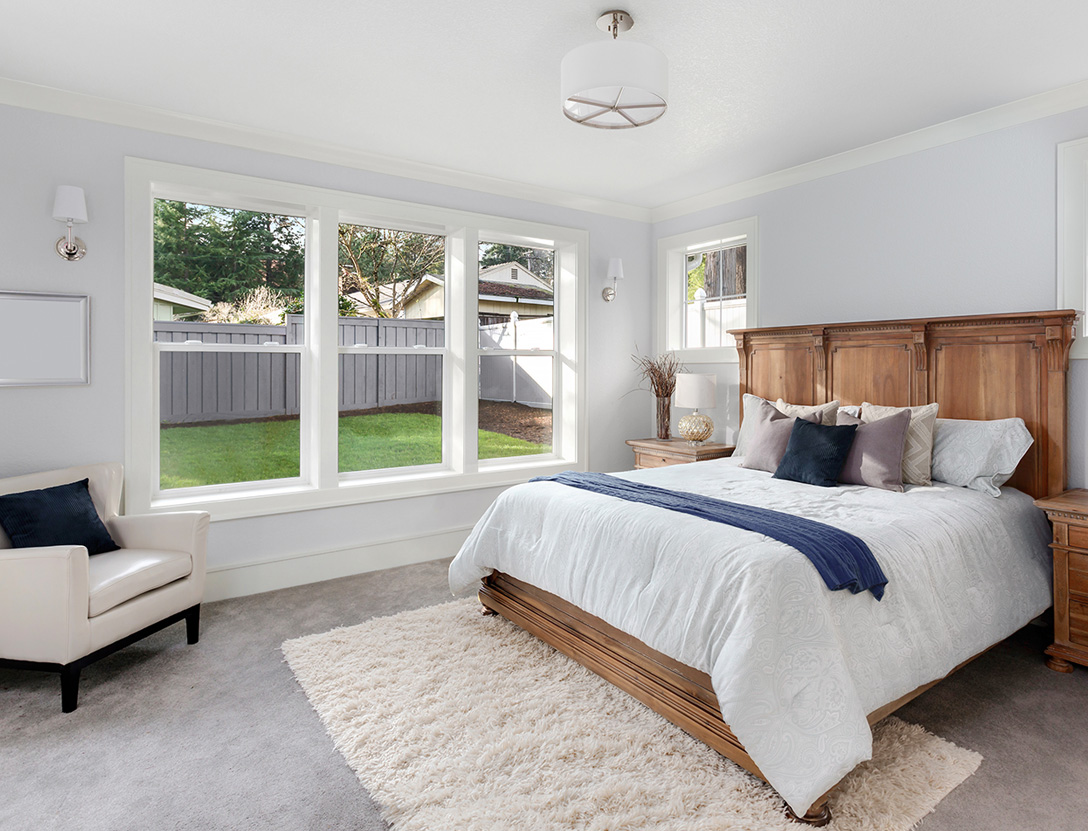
xmin=0 ymin=77 xmax=651 ymax=222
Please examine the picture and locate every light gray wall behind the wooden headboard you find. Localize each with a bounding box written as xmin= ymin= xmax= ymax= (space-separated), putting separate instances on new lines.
xmin=653 ymin=103 xmax=1088 ymax=487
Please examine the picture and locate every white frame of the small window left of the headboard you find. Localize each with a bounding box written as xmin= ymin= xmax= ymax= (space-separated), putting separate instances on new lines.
xmin=655 ymin=216 xmax=759 ymax=363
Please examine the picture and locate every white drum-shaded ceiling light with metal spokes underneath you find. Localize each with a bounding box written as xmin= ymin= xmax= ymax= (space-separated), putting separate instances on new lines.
xmin=559 ymin=9 xmax=669 ymax=129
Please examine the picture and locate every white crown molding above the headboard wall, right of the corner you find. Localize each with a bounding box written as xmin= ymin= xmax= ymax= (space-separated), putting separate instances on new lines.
xmin=651 ymin=80 xmax=1088 ymax=222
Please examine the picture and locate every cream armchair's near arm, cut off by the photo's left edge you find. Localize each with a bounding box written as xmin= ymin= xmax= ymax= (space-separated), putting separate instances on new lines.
xmin=0 ymin=545 xmax=90 ymax=663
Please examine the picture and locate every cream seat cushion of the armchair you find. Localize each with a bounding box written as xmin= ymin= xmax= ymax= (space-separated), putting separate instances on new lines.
xmin=87 ymin=548 xmax=193 ymax=618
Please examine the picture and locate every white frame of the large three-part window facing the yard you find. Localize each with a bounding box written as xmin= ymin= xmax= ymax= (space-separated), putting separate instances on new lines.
xmin=125 ymin=158 xmax=589 ymax=520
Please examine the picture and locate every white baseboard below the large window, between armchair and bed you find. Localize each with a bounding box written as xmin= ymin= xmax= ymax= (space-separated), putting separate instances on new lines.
xmin=203 ymin=525 xmax=472 ymax=603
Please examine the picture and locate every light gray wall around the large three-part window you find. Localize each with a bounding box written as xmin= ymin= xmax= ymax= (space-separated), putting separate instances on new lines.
xmin=0 ymin=107 xmax=652 ymax=566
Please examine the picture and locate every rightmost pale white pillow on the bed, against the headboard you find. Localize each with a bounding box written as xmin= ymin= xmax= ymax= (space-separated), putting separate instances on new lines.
xmin=934 ymin=419 xmax=1035 ymax=496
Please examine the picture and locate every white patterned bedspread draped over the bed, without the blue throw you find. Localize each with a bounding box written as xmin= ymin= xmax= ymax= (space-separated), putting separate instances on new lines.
xmin=449 ymin=459 xmax=1051 ymax=813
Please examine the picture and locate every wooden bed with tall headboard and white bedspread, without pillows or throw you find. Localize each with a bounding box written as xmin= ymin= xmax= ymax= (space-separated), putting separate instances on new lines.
xmin=450 ymin=311 xmax=1076 ymax=824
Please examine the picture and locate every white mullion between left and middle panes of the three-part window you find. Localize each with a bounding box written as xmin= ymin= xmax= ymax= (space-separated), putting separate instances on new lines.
xmin=311 ymin=208 xmax=339 ymax=488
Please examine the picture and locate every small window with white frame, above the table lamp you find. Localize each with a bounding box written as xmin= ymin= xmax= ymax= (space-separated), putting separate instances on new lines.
xmin=657 ymin=218 xmax=757 ymax=361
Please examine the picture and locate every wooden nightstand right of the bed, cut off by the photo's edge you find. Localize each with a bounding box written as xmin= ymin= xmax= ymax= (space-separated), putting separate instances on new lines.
xmin=1035 ymin=489 xmax=1088 ymax=672
